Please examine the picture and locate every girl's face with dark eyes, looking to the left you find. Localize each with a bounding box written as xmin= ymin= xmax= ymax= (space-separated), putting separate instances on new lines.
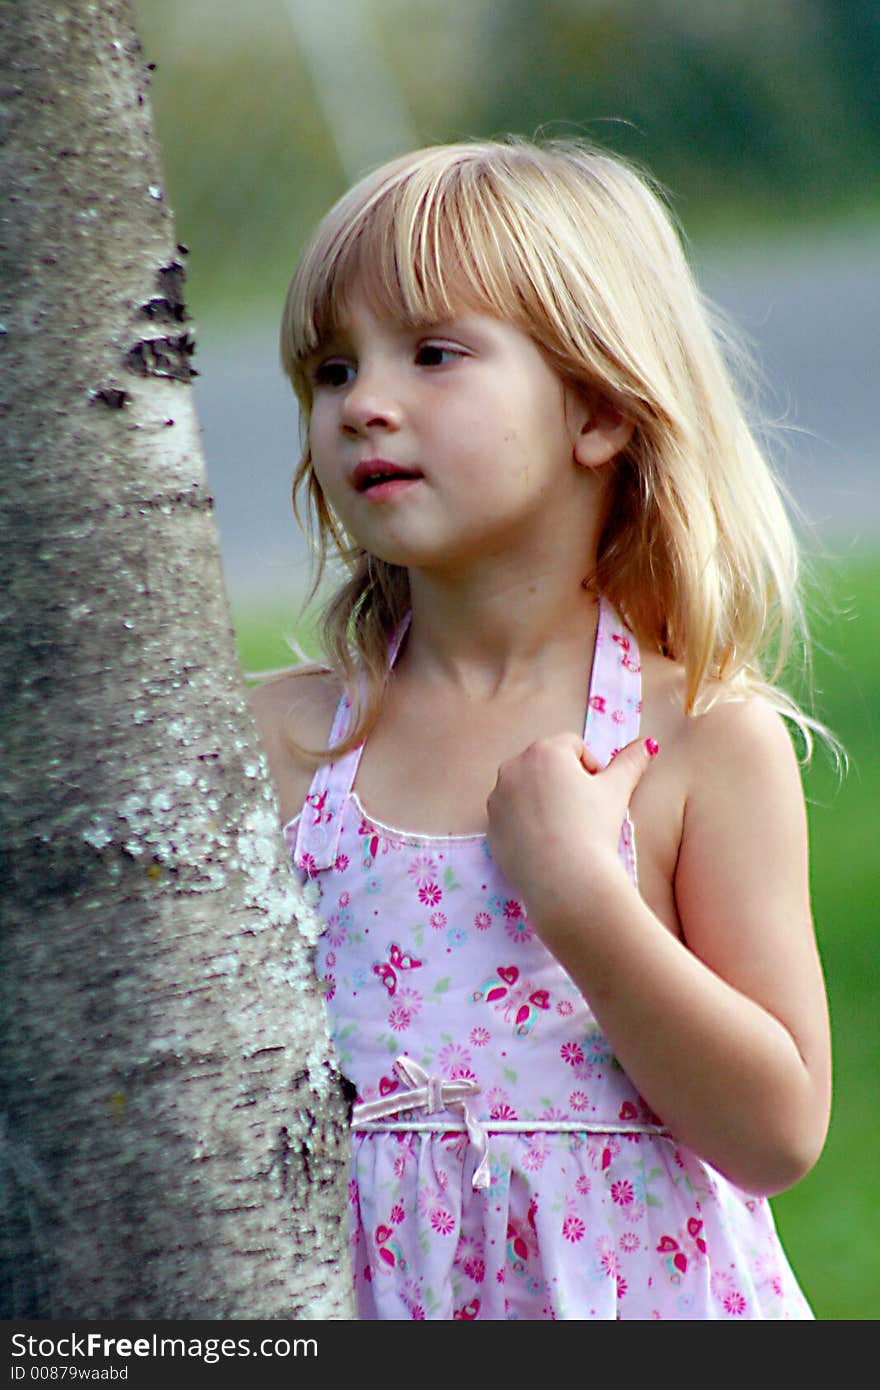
xmin=307 ymin=293 xmax=595 ymax=581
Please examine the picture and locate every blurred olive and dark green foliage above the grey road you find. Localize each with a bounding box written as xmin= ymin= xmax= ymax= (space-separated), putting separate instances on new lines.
xmin=136 ymin=0 xmax=880 ymax=313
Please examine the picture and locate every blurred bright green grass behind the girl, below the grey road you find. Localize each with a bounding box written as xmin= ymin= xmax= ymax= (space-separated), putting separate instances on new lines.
xmin=229 ymin=553 xmax=880 ymax=1321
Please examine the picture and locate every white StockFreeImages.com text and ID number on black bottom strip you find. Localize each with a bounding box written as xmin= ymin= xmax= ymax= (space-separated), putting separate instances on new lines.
xmin=10 ymin=1332 xmax=318 ymax=1380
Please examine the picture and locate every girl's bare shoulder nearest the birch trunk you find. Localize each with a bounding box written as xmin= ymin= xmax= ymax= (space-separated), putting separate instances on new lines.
xmin=249 ymin=666 xmax=342 ymax=823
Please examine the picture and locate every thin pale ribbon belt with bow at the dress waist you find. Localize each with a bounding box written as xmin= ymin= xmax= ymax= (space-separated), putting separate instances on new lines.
xmin=352 ymin=1056 xmax=673 ymax=1190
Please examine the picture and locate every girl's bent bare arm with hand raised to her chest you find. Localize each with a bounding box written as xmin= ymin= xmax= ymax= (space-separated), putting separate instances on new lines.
xmin=489 ymin=699 xmax=830 ymax=1193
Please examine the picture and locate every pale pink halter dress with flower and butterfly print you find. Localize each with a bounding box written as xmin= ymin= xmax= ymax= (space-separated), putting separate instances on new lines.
xmin=285 ymin=602 xmax=812 ymax=1319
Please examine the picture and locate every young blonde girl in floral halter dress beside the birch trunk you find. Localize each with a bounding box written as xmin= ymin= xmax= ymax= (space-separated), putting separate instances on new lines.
xmin=254 ymin=142 xmax=830 ymax=1319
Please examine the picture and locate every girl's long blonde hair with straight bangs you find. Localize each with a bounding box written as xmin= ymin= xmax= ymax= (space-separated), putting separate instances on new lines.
xmin=281 ymin=139 xmax=815 ymax=752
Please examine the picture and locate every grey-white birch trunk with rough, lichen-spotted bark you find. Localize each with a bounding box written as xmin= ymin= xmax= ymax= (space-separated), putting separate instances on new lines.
xmin=0 ymin=0 xmax=352 ymax=1319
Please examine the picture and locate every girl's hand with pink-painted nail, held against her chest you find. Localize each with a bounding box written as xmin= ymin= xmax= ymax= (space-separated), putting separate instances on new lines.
xmin=487 ymin=734 xmax=658 ymax=928
